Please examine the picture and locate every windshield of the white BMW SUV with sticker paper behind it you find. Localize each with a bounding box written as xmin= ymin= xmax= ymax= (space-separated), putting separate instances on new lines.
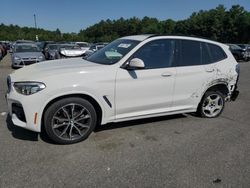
xmin=87 ymin=39 xmax=140 ymax=65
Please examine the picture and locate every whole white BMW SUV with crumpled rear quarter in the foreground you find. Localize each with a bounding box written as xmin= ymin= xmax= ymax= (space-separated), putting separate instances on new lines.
xmin=7 ymin=35 xmax=239 ymax=144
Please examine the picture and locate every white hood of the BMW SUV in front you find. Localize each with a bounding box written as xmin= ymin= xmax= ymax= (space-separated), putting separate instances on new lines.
xmin=11 ymin=58 xmax=105 ymax=82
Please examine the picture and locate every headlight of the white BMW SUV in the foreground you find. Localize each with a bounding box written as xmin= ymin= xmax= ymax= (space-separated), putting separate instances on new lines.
xmin=14 ymin=82 xmax=46 ymax=95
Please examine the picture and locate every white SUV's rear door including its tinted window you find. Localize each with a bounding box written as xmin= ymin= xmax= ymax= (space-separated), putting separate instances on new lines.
xmin=173 ymin=40 xmax=211 ymax=110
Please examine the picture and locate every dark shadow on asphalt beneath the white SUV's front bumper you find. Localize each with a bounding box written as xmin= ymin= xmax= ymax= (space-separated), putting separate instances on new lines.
xmin=6 ymin=115 xmax=38 ymax=141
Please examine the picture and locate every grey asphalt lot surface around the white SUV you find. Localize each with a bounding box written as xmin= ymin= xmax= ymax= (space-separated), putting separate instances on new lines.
xmin=0 ymin=53 xmax=250 ymax=188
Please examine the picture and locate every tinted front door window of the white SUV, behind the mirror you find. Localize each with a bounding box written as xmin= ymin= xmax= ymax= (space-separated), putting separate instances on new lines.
xmin=133 ymin=39 xmax=175 ymax=69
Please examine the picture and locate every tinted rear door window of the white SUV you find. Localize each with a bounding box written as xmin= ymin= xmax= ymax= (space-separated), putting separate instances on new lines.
xmin=178 ymin=40 xmax=202 ymax=66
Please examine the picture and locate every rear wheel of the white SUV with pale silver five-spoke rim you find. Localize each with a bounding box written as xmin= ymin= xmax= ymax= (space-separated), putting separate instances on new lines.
xmin=197 ymin=91 xmax=225 ymax=118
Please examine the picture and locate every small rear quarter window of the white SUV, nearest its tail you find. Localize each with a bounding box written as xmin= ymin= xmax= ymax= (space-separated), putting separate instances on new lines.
xmin=207 ymin=43 xmax=227 ymax=63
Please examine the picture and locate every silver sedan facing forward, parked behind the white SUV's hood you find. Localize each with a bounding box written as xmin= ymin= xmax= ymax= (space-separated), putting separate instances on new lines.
xmin=11 ymin=43 xmax=45 ymax=68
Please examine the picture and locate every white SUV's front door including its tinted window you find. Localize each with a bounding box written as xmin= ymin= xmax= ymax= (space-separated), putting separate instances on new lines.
xmin=115 ymin=39 xmax=176 ymax=119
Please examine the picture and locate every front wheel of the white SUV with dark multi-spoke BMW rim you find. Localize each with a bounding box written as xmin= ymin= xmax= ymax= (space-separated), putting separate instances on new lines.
xmin=44 ymin=97 xmax=97 ymax=144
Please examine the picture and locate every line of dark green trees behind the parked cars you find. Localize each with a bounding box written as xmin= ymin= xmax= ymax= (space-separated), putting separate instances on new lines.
xmin=0 ymin=5 xmax=250 ymax=43
